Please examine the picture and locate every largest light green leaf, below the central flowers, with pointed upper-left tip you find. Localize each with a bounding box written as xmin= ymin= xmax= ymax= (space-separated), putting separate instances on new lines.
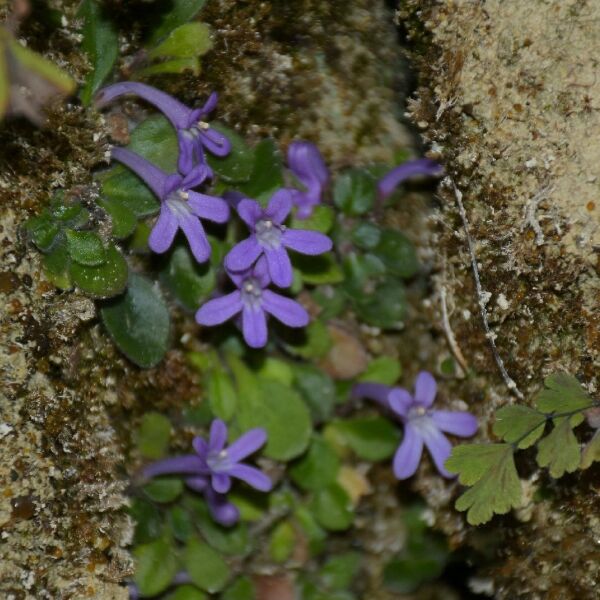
xmin=229 ymin=356 xmax=312 ymax=461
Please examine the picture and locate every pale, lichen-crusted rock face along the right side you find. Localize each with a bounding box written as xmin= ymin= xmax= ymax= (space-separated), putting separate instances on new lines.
xmin=399 ymin=0 xmax=600 ymax=598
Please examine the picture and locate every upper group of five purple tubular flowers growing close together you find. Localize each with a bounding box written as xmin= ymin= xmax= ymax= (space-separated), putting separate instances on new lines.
xmin=96 ymin=82 xmax=332 ymax=348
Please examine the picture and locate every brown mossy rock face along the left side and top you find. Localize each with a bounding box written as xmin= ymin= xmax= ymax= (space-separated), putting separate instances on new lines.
xmin=0 ymin=0 xmax=418 ymax=600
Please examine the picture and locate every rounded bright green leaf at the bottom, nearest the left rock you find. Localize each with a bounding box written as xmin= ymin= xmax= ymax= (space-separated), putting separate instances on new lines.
xmin=133 ymin=539 xmax=177 ymax=596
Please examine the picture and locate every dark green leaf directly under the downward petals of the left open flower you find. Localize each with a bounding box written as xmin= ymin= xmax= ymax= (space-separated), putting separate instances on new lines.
xmin=160 ymin=244 xmax=216 ymax=310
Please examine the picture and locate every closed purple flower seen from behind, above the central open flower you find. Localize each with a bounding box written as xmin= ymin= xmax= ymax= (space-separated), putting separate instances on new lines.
xmin=288 ymin=142 xmax=329 ymax=219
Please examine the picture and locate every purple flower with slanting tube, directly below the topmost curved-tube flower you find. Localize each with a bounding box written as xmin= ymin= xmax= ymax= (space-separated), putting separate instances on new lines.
xmin=112 ymin=148 xmax=229 ymax=262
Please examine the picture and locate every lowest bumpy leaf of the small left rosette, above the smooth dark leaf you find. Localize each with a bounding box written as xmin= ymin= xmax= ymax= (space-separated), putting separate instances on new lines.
xmin=70 ymin=245 xmax=128 ymax=298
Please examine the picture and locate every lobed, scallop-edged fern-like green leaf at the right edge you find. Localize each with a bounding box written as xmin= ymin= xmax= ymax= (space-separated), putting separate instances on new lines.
xmin=446 ymin=373 xmax=600 ymax=525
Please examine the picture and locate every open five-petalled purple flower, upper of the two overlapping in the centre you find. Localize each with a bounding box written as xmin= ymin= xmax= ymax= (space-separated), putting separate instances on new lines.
xmin=225 ymin=189 xmax=332 ymax=287
